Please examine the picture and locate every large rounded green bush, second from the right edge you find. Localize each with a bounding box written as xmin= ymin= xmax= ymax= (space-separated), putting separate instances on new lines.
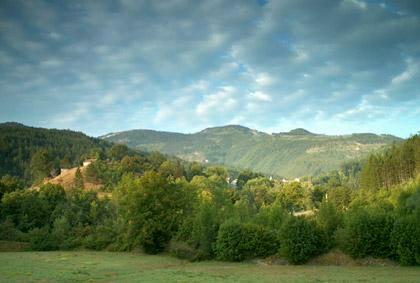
xmin=339 ymin=208 xmax=394 ymax=258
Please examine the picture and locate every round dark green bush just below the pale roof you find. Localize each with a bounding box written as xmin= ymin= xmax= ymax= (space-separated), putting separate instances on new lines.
xmin=279 ymin=217 xmax=325 ymax=264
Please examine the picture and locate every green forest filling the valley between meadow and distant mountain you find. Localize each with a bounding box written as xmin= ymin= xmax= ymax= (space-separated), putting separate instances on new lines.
xmin=0 ymin=123 xmax=420 ymax=265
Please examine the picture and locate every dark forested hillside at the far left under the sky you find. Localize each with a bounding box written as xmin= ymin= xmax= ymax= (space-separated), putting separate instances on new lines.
xmin=0 ymin=123 xmax=111 ymax=183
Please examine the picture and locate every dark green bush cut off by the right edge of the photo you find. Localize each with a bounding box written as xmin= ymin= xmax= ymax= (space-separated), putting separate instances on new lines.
xmin=391 ymin=216 xmax=420 ymax=265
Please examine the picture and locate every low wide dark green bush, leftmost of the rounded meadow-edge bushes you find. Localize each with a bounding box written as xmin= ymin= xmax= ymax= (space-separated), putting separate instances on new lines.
xmin=215 ymin=221 xmax=278 ymax=261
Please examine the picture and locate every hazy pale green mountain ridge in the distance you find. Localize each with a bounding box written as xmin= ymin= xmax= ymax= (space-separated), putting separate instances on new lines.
xmin=101 ymin=125 xmax=402 ymax=178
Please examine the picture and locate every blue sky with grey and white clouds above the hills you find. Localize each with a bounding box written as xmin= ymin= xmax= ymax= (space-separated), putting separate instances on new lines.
xmin=0 ymin=0 xmax=420 ymax=137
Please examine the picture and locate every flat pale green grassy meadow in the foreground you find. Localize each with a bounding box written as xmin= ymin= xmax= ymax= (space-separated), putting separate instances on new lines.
xmin=0 ymin=251 xmax=420 ymax=282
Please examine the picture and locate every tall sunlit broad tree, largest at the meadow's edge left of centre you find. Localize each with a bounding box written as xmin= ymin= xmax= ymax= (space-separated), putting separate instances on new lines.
xmin=115 ymin=171 xmax=194 ymax=253
